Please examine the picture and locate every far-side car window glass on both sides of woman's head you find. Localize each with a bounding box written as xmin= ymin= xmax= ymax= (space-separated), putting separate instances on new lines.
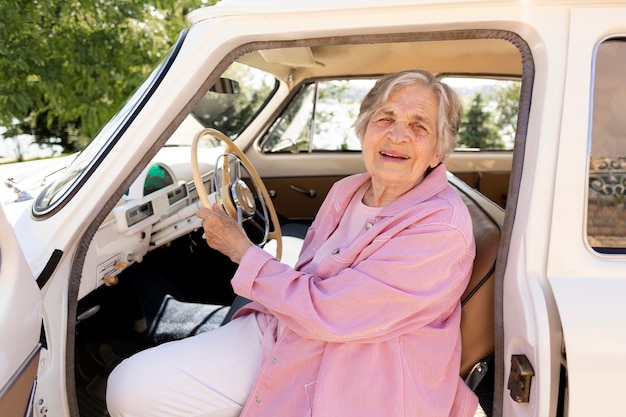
xmin=262 ymin=77 xmax=520 ymax=153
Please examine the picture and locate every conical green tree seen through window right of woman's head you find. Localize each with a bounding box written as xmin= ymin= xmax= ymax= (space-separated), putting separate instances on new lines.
xmin=458 ymin=93 xmax=504 ymax=149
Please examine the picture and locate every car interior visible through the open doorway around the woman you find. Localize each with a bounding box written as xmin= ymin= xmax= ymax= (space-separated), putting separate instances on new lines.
xmin=68 ymin=29 xmax=533 ymax=417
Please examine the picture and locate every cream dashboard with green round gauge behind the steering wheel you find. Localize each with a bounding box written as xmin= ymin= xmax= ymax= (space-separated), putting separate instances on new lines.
xmin=78 ymin=146 xmax=223 ymax=299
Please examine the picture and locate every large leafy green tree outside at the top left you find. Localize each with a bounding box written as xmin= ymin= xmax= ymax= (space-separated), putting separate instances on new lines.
xmin=0 ymin=0 xmax=218 ymax=159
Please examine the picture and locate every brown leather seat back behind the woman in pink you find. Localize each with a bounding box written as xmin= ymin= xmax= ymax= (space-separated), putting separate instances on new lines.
xmin=459 ymin=192 xmax=501 ymax=377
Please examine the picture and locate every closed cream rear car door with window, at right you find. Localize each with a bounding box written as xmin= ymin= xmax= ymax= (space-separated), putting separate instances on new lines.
xmin=547 ymin=7 xmax=626 ymax=416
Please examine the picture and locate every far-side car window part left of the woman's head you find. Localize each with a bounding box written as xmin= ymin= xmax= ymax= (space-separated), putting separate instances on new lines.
xmin=261 ymin=79 xmax=376 ymax=153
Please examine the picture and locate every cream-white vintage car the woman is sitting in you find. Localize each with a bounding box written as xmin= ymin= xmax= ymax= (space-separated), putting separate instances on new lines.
xmin=0 ymin=0 xmax=626 ymax=417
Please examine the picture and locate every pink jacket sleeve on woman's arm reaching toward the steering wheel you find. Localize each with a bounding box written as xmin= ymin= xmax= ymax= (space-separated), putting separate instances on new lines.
xmin=232 ymin=218 xmax=474 ymax=342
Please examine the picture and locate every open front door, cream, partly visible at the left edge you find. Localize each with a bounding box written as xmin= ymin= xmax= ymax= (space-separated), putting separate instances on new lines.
xmin=0 ymin=209 xmax=42 ymax=417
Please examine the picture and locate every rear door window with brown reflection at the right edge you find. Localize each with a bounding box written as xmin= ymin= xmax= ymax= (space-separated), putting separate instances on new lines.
xmin=587 ymin=38 xmax=626 ymax=254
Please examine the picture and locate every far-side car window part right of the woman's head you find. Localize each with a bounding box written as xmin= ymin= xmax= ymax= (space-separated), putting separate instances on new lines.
xmin=442 ymin=76 xmax=521 ymax=151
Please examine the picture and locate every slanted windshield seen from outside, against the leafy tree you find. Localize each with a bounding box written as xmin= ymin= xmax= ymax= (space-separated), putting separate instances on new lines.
xmin=33 ymin=32 xmax=186 ymax=216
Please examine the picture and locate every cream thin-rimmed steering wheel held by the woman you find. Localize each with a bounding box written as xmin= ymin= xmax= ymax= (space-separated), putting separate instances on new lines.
xmin=191 ymin=128 xmax=283 ymax=260
